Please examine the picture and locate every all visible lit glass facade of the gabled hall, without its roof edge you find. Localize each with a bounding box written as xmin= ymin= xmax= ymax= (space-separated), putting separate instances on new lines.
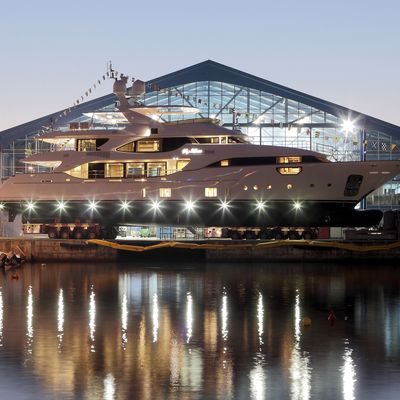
xmin=1 ymin=76 xmax=400 ymax=208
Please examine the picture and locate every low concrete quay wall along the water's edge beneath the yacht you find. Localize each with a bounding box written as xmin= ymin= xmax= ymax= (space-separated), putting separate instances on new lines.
xmin=0 ymin=237 xmax=400 ymax=262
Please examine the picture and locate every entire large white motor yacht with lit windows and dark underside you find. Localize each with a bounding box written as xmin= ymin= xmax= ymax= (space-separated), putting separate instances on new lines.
xmin=0 ymin=77 xmax=400 ymax=233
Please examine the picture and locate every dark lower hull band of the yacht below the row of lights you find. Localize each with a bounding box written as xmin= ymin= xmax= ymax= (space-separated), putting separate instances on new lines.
xmin=6 ymin=200 xmax=382 ymax=227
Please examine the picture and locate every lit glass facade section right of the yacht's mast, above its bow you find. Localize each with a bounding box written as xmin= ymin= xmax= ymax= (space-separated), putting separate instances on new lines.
xmin=143 ymin=81 xmax=399 ymax=161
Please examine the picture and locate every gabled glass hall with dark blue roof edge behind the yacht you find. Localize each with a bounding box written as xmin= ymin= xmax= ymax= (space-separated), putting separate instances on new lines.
xmin=0 ymin=60 xmax=400 ymax=208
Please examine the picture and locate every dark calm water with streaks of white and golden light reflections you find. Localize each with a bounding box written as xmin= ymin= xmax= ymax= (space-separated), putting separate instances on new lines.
xmin=0 ymin=264 xmax=400 ymax=400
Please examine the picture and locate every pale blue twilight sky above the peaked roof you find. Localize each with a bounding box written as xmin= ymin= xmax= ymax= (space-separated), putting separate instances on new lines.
xmin=0 ymin=0 xmax=400 ymax=131
